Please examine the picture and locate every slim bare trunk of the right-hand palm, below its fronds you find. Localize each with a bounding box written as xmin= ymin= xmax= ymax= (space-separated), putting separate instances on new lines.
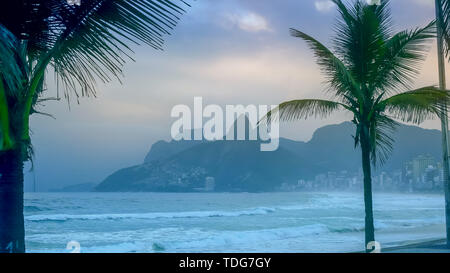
xmin=361 ymin=126 xmax=375 ymax=252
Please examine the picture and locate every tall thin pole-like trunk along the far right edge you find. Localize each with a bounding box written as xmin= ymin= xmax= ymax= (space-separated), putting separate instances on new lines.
xmin=435 ymin=0 xmax=450 ymax=248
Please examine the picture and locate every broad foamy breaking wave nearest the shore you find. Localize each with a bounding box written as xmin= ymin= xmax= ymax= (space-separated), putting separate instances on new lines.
xmin=27 ymin=218 xmax=442 ymax=253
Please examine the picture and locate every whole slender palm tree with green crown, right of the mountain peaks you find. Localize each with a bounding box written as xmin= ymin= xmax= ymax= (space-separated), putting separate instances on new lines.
xmin=266 ymin=0 xmax=449 ymax=251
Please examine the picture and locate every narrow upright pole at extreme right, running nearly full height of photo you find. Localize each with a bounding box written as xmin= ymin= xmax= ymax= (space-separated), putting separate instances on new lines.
xmin=435 ymin=0 xmax=450 ymax=248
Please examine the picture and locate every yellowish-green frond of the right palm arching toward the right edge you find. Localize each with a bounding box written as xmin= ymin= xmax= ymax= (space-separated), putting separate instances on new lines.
xmin=377 ymin=86 xmax=450 ymax=124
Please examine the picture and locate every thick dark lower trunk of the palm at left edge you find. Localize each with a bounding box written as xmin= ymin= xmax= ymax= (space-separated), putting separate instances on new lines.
xmin=0 ymin=145 xmax=25 ymax=253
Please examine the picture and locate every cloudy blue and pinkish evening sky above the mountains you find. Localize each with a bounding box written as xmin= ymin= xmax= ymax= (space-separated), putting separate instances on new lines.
xmin=25 ymin=0 xmax=446 ymax=191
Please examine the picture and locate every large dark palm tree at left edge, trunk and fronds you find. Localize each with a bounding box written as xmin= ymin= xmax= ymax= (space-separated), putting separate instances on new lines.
xmin=0 ymin=0 xmax=188 ymax=252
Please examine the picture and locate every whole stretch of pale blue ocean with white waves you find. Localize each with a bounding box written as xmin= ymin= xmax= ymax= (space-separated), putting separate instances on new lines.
xmin=25 ymin=192 xmax=445 ymax=253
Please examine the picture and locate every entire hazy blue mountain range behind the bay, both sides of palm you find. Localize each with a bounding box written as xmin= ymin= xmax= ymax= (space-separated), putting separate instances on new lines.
xmin=96 ymin=122 xmax=441 ymax=192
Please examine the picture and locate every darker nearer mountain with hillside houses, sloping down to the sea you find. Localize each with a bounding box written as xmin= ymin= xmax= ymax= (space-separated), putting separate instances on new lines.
xmin=96 ymin=141 xmax=316 ymax=192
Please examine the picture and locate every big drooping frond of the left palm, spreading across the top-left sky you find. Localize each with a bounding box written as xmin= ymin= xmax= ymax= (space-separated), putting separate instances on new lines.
xmin=46 ymin=0 xmax=191 ymax=99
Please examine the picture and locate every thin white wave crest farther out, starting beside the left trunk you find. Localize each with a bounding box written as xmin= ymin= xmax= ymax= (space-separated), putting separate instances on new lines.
xmin=25 ymin=207 xmax=275 ymax=222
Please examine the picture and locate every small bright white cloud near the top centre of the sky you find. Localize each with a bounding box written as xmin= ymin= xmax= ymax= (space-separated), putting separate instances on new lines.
xmin=225 ymin=12 xmax=271 ymax=32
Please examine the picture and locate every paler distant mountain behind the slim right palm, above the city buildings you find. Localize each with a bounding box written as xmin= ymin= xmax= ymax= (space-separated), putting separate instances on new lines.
xmin=280 ymin=122 xmax=442 ymax=172
